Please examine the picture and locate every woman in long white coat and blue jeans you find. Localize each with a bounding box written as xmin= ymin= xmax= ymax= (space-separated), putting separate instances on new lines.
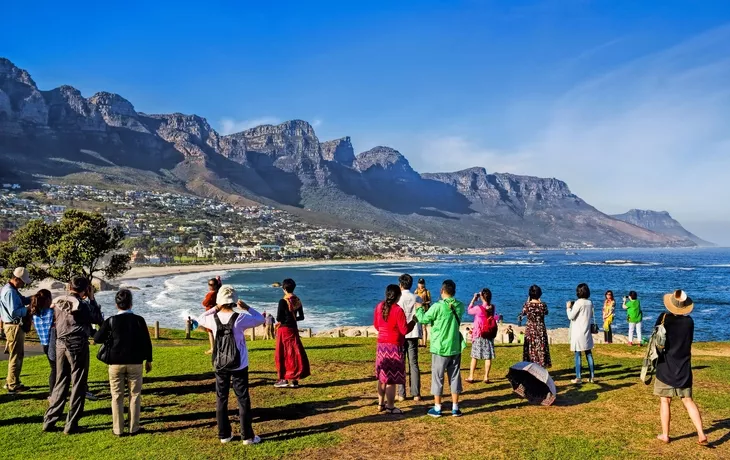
xmin=567 ymin=283 xmax=594 ymax=383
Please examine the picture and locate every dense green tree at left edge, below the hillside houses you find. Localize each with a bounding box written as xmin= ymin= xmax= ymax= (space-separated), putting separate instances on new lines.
xmin=0 ymin=209 xmax=129 ymax=282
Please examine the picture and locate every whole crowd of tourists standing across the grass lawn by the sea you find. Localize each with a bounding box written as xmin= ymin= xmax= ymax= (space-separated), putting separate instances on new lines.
xmin=0 ymin=267 xmax=707 ymax=445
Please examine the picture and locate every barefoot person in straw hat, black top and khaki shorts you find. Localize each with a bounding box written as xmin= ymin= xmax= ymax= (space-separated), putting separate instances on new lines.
xmin=654 ymin=289 xmax=707 ymax=446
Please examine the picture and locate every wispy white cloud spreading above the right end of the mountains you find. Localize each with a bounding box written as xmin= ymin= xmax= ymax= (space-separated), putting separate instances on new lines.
xmin=410 ymin=26 xmax=730 ymax=220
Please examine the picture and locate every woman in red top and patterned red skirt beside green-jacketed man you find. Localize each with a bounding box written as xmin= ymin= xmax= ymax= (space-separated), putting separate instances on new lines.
xmin=373 ymin=284 xmax=416 ymax=415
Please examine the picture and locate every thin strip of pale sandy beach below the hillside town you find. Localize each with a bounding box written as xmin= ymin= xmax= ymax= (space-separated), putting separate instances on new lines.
xmin=116 ymin=257 xmax=429 ymax=284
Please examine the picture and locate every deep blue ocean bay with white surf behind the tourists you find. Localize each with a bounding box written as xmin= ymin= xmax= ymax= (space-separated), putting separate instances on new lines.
xmin=98 ymin=248 xmax=730 ymax=341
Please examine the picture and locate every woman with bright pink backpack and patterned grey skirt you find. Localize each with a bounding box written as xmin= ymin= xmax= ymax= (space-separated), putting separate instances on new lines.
xmin=466 ymin=288 xmax=497 ymax=383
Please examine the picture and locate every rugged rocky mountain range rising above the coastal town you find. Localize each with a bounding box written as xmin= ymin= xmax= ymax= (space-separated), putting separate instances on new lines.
xmin=0 ymin=58 xmax=701 ymax=247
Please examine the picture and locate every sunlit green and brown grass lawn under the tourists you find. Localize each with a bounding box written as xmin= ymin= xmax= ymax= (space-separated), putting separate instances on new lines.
xmin=0 ymin=331 xmax=730 ymax=459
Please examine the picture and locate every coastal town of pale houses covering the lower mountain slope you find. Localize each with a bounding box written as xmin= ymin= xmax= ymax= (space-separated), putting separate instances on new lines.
xmin=0 ymin=184 xmax=456 ymax=265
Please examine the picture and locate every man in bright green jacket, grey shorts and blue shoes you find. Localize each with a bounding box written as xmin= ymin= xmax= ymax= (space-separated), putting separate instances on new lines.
xmin=416 ymin=280 xmax=466 ymax=417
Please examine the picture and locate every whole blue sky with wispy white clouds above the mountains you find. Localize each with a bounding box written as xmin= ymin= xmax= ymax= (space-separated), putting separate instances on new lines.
xmin=0 ymin=0 xmax=730 ymax=243
